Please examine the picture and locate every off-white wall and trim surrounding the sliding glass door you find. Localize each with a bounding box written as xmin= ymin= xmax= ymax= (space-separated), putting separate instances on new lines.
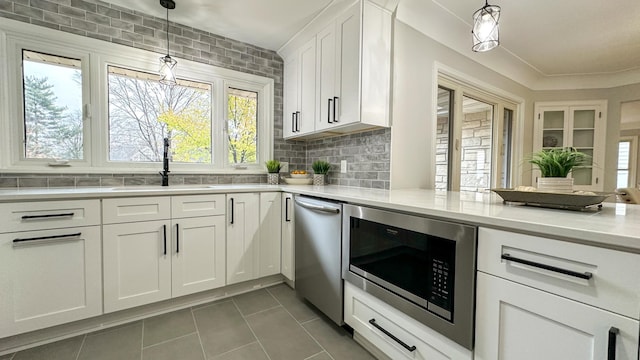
xmin=391 ymin=20 xmax=533 ymax=189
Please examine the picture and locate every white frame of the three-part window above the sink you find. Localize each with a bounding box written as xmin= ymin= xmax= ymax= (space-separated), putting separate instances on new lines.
xmin=0 ymin=19 xmax=274 ymax=174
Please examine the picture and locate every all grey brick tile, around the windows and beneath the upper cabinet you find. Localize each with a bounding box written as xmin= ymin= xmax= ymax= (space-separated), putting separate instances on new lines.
xmin=0 ymin=0 xmax=391 ymax=189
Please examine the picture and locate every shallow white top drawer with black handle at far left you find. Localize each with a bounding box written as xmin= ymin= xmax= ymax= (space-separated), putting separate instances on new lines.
xmin=0 ymin=200 xmax=100 ymax=232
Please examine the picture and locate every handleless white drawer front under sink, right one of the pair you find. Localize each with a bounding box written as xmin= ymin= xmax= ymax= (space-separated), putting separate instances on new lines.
xmin=171 ymin=194 xmax=225 ymax=219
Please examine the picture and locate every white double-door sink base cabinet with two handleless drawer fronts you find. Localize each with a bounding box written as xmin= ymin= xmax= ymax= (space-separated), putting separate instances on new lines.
xmin=103 ymin=195 xmax=226 ymax=312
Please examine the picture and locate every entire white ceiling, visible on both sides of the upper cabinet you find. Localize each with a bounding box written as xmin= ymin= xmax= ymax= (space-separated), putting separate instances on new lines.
xmin=102 ymin=0 xmax=640 ymax=88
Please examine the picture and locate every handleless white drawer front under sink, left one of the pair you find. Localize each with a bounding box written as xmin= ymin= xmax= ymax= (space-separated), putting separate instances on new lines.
xmin=102 ymin=196 xmax=171 ymax=224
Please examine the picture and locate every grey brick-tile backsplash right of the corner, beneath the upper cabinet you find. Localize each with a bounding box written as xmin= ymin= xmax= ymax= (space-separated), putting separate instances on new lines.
xmin=307 ymin=129 xmax=391 ymax=189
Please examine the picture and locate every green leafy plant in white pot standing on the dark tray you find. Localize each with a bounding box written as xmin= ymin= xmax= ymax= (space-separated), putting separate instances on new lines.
xmin=529 ymin=147 xmax=590 ymax=192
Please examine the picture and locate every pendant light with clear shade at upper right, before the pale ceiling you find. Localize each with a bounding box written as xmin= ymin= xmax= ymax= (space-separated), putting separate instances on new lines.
xmin=471 ymin=0 xmax=500 ymax=52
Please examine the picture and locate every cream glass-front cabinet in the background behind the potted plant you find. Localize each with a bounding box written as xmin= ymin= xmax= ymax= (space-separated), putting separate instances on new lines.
xmin=532 ymin=100 xmax=607 ymax=191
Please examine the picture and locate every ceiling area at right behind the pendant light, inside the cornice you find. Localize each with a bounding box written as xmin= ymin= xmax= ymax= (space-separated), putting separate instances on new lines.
xmin=434 ymin=0 xmax=640 ymax=76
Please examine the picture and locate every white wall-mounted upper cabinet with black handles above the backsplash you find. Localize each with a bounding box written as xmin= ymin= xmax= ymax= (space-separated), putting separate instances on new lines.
xmin=280 ymin=0 xmax=393 ymax=138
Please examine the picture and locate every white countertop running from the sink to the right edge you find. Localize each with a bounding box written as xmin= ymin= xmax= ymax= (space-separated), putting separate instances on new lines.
xmin=0 ymin=184 xmax=640 ymax=253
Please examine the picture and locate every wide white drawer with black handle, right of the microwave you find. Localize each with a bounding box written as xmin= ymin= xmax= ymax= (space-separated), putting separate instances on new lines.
xmin=478 ymin=228 xmax=640 ymax=319
